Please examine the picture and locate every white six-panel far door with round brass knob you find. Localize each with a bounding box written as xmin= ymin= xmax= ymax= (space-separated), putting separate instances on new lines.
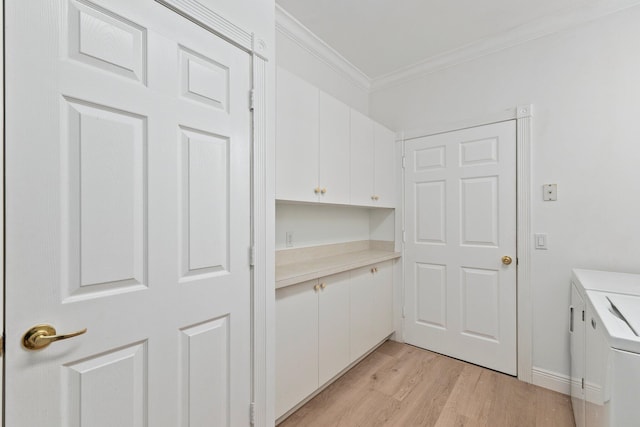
xmin=405 ymin=121 xmax=517 ymax=375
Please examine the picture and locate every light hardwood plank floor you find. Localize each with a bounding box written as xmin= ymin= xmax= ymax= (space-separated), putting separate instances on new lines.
xmin=280 ymin=341 xmax=575 ymax=427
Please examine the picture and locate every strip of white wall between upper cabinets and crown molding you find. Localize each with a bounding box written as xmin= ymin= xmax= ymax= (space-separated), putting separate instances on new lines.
xmin=276 ymin=31 xmax=369 ymax=114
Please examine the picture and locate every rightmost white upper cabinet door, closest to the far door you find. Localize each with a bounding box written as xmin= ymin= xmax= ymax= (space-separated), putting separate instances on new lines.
xmin=373 ymin=123 xmax=396 ymax=208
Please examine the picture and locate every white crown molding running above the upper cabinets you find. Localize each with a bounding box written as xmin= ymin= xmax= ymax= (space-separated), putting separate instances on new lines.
xmin=276 ymin=4 xmax=371 ymax=91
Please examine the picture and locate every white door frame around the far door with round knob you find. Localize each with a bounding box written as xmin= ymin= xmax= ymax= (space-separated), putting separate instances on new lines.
xmin=396 ymin=104 xmax=533 ymax=383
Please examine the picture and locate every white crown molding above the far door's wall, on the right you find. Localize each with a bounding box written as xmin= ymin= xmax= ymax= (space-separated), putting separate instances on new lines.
xmin=371 ymin=0 xmax=640 ymax=92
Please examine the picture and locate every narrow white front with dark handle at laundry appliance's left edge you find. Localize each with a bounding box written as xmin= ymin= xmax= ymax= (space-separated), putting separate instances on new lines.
xmin=569 ymin=283 xmax=585 ymax=427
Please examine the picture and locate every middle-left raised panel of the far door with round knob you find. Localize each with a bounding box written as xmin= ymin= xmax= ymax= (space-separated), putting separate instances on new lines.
xmin=414 ymin=181 xmax=447 ymax=244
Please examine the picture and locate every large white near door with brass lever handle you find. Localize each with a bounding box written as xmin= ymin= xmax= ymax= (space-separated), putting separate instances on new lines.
xmin=5 ymin=0 xmax=251 ymax=427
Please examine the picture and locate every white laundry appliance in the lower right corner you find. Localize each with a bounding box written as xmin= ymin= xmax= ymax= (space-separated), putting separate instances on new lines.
xmin=570 ymin=270 xmax=640 ymax=427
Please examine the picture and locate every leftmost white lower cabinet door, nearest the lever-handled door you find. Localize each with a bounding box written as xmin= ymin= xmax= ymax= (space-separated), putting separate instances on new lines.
xmin=275 ymin=280 xmax=318 ymax=418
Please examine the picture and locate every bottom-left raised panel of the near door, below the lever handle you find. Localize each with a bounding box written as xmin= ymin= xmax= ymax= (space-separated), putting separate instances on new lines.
xmin=60 ymin=342 xmax=148 ymax=427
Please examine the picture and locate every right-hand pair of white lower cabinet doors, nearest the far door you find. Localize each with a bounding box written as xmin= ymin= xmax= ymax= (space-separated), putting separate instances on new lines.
xmin=350 ymin=261 xmax=393 ymax=362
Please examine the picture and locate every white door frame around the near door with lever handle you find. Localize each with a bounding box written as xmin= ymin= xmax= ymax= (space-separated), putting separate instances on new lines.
xmin=0 ymin=0 xmax=275 ymax=426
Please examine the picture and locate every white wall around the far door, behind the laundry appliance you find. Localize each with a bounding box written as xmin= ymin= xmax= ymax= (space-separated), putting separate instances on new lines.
xmin=370 ymin=7 xmax=640 ymax=377
